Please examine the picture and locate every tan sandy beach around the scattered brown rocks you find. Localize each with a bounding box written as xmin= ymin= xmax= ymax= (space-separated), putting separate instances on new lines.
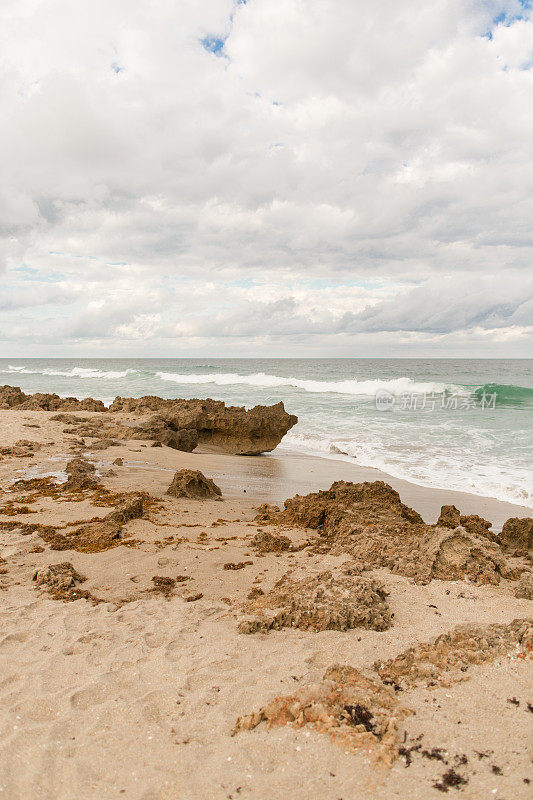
xmin=0 ymin=411 xmax=533 ymax=800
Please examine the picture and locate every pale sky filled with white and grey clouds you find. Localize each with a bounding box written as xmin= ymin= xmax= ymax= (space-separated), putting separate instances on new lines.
xmin=0 ymin=0 xmax=533 ymax=357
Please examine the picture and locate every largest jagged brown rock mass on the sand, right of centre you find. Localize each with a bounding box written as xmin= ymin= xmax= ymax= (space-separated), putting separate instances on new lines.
xmin=263 ymin=481 xmax=510 ymax=584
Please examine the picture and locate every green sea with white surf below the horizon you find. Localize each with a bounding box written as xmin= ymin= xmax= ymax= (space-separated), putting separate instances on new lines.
xmin=0 ymin=359 xmax=533 ymax=507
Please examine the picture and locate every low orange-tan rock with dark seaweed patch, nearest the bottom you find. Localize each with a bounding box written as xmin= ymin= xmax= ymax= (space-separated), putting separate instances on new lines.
xmin=233 ymin=665 xmax=412 ymax=766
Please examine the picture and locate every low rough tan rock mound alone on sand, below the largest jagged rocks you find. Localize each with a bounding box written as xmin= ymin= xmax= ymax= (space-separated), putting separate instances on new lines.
xmin=239 ymin=570 xmax=391 ymax=633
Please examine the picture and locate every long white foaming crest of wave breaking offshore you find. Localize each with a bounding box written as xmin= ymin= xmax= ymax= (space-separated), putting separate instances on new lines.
xmin=156 ymin=372 xmax=462 ymax=397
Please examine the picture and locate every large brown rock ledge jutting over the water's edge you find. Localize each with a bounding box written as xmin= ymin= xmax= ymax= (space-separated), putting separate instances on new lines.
xmin=0 ymin=386 xmax=298 ymax=455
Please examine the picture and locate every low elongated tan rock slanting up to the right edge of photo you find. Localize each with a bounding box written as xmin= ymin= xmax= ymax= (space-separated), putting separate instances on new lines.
xmin=374 ymin=618 xmax=533 ymax=688
